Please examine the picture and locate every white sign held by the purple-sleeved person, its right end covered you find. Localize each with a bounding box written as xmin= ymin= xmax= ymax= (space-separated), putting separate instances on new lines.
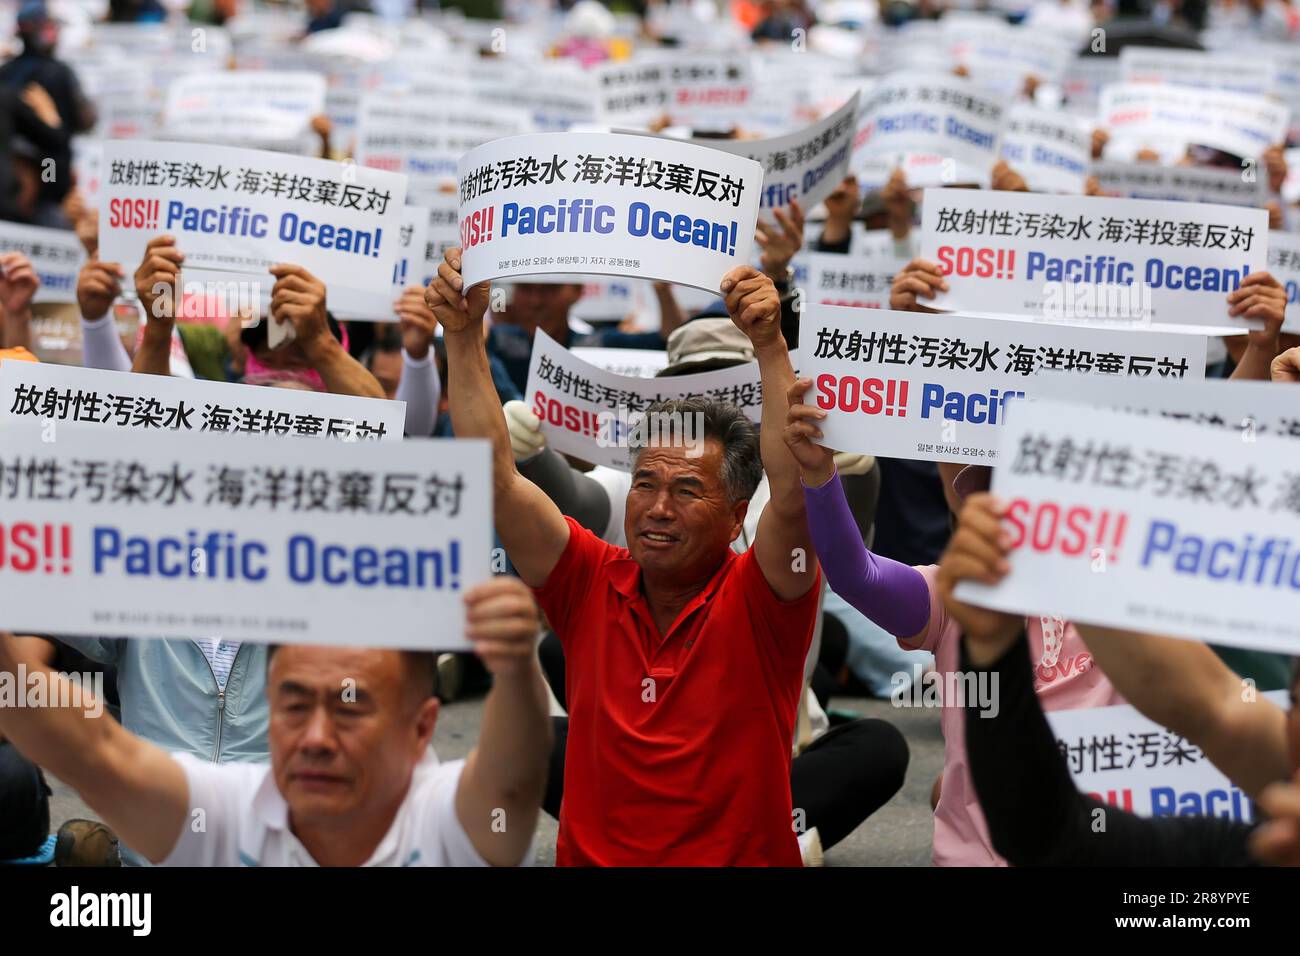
xmin=800 ymin=303 xmax=1205 ymax=464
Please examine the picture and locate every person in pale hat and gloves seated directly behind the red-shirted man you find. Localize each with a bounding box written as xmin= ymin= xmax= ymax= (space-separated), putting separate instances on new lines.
xmin=503 ymin=319 xmax=907 ymax=862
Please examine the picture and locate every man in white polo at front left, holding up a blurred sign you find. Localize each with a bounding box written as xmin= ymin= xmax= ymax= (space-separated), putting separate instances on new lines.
xmin=0 ymin=578 xmax=550 ymax=866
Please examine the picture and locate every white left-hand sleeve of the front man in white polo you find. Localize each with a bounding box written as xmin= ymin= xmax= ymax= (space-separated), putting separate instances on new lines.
xmin=159 ymin=753 xmax=256 ymax=866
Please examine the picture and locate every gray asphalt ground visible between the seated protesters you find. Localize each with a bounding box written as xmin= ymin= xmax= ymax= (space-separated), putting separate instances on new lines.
xmin=49 ymin=697 xmax=944 ymax=866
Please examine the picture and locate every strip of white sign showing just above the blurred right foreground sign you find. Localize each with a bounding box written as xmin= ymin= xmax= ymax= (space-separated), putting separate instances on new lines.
xmin=1024 ymin=376 xmax=1300 ymax=441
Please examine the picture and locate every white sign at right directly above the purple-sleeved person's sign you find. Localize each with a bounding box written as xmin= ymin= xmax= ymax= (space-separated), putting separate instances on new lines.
xmin=920 ymin=189 xmax=1269 ymax=334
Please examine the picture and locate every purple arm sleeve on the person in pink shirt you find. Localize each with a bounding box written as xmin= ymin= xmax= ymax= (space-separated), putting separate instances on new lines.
xmin=803 ymin=472 xmax=930 ymax=637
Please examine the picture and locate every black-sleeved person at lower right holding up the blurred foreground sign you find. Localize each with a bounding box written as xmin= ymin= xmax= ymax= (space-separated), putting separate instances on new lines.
xmin=937 ymin=494 xmax=1300 ymax=866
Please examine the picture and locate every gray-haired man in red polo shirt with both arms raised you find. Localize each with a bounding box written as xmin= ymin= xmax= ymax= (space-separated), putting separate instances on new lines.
xmin=425 ymin=248 xmax=819 ymax=866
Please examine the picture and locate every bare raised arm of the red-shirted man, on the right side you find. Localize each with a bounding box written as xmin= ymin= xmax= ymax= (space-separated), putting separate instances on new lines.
xmin=722 ymin=265 xmax=818 ymax=601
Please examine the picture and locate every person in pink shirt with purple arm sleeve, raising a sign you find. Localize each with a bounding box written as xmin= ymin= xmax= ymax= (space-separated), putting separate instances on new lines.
xmin=785 ymin=378 xmax=1123 ymax=866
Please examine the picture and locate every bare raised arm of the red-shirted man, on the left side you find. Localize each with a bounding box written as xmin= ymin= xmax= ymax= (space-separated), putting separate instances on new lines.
xmin=424 ymin=248 xmax=569 ymax=588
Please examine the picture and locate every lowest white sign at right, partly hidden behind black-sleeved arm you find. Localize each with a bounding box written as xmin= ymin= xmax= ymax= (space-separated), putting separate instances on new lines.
xmin=1045 ymin=691 xmax=1287 ymax=823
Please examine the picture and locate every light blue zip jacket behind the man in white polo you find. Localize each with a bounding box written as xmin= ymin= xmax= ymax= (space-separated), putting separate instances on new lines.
xmin=57 ymin=636 xmax=269 ymax=763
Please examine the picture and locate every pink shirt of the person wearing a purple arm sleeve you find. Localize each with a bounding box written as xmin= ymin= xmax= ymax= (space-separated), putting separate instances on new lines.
xmin=898 ymin=564 xmax=1125 ymax=866
